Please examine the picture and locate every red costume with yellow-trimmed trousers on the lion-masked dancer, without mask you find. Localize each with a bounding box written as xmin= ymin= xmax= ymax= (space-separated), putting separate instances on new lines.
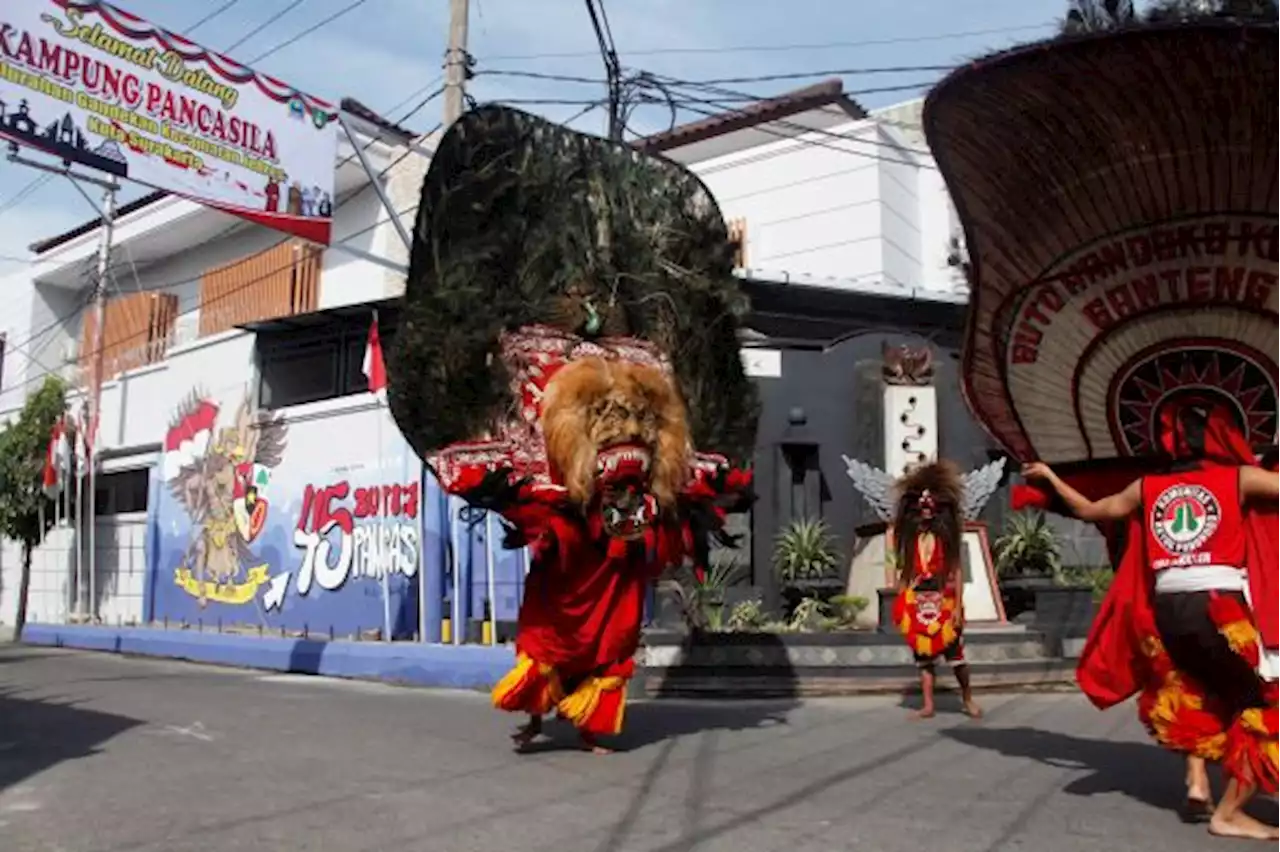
xmin=434 ymin=326 xmax=751 ymax=736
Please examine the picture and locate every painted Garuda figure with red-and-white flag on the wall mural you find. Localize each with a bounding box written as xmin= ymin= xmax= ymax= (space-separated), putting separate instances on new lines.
xmin=163 ymin=391 xmax=287 ymax=606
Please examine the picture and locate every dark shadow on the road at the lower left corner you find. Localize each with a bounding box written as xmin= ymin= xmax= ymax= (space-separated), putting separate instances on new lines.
xmin=0 ymin=690 xmax=143 ymax=791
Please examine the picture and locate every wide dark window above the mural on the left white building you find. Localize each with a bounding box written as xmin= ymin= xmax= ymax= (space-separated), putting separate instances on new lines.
xmin=257 ymin=312 xmax=396 ymax=409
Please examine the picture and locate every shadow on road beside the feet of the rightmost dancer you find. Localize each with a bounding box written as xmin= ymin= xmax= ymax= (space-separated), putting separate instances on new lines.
xmin=938 ymin=727 xmax=1184 ymax=809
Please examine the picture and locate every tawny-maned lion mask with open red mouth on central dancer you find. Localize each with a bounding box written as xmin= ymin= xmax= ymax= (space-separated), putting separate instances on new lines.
xmin=541 ymin=357 xmax=690 ymax=539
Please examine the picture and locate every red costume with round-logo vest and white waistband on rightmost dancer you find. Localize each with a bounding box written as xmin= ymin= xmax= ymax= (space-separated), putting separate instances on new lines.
xmin=1015 ymin=407 xmax=1280 ymax=793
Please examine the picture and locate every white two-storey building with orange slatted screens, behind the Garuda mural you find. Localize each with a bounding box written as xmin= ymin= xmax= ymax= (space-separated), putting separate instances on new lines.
xmin=0 ymin=101 xmax=426 ymax=624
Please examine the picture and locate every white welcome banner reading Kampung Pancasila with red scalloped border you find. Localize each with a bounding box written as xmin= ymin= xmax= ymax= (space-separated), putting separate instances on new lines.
xmin=0 ymin=0 xmax=338 ymax=244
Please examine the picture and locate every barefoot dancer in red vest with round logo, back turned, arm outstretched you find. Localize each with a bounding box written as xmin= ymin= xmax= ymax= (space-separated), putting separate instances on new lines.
xmin=1023 ymin=404 xmax=1280 ymax=840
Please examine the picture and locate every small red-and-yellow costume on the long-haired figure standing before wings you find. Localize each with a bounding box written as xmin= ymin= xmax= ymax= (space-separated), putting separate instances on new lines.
xmin=893 ymin=536 xmax=964 ymax=663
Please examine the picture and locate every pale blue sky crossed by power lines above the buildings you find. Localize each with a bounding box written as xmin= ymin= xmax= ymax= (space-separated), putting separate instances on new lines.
xmin=0 ymin=0 xmax=1066 ymax=272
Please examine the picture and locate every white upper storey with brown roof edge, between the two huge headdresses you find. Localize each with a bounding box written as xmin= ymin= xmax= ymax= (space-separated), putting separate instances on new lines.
xmin=644 ymin=79 xmax=957 ymax=294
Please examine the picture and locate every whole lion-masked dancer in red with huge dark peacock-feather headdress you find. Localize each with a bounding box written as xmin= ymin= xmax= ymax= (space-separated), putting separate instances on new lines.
xmin=387 ymin=104 xmax=758 ymax=751
